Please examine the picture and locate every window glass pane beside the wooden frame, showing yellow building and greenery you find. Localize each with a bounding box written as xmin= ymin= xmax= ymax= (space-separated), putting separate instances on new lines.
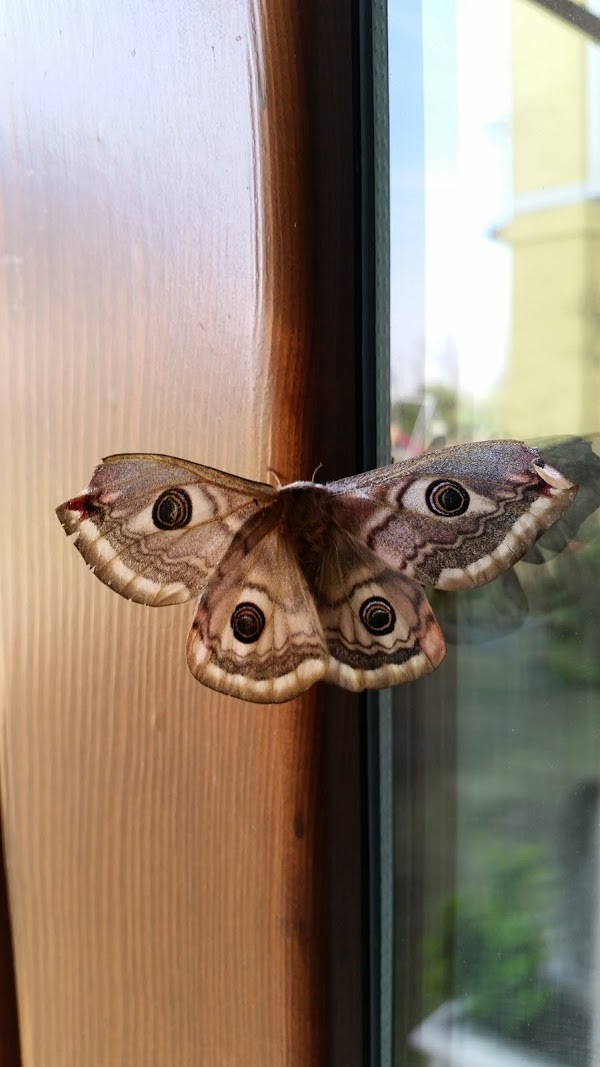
xmin=389 ymin=0 xmax=600 ymax=1067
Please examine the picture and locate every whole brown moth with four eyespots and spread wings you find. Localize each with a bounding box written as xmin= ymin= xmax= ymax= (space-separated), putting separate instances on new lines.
xmin=57 ymin=441 xmax=577 ymax=703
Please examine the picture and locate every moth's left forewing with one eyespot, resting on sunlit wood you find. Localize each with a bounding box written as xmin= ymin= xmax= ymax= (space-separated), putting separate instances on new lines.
xmin=57 ymin=455 xmax=277 ymax=606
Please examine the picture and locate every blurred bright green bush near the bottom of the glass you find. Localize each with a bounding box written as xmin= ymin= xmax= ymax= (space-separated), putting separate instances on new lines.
xmin=426 ymin=845 xmax=550 ymax=1036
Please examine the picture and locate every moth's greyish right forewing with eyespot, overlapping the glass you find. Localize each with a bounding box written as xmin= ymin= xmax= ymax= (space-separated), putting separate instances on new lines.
xmin=328 ymin=441 xmax=577 ymax=589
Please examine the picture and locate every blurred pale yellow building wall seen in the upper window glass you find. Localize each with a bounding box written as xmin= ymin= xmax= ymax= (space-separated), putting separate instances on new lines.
xmin=501 ymin=0 xmax=600 ymax=437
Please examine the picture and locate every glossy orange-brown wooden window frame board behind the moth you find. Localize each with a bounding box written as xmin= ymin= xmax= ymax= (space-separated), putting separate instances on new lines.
xmin=0 ymin=0 xmax=339 ymax=1067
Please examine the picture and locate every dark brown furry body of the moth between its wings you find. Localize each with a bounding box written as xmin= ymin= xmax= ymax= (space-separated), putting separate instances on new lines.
xmin=280 ymin=481 xmax=335 ymax=588
